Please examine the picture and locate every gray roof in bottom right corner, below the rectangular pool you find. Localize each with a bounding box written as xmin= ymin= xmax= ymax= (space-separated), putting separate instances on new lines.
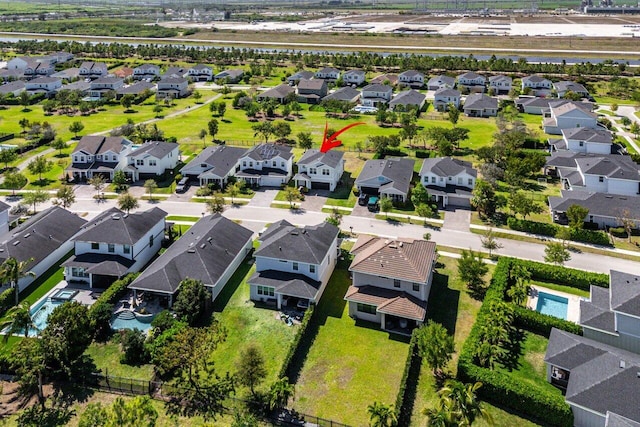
xmin=545 ymin=328 xmax=640 ymax=422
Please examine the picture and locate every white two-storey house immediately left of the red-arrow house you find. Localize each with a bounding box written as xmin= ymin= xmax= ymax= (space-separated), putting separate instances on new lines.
xmin=236 ymin=144 xmax=293 ymax=187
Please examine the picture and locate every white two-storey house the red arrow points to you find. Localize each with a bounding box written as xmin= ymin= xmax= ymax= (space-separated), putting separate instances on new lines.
xmin=293 ymin=149 xmax=344 ymax=191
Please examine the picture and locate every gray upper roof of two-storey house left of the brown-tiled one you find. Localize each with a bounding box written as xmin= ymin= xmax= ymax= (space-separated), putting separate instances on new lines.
xmin=255 ymin=222 xmax=340 ymax=264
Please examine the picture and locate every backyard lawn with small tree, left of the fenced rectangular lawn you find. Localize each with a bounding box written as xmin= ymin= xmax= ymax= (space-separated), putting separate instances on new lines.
xmin=211 ymin=261 xmax=298 ymax=390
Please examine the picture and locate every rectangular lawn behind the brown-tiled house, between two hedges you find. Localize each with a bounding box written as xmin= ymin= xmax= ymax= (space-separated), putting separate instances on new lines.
xmin=293 ymin=268 xmax=408 ymax=426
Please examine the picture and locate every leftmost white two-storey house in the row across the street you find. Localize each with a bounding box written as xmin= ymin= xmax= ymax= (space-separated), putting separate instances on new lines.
xmin=66 ymin=135 xmax=136 ymax=182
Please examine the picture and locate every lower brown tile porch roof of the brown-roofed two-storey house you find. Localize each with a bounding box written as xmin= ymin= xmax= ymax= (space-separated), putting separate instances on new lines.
xmin=344 ymin=285 xmax=427 ymax=321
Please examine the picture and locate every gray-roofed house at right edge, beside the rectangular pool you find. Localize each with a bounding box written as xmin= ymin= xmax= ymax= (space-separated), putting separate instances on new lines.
xmin=580 ymin=270 xmax=640 ymax=353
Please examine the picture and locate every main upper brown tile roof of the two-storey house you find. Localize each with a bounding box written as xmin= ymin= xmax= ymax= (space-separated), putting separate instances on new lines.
xmin=349 ymin=235 xmax=436 ymax=283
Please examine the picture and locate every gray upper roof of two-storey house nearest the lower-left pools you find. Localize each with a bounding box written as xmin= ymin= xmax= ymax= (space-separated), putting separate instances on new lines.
xmin=73 ymin=208 xmax=167 ymax=246
